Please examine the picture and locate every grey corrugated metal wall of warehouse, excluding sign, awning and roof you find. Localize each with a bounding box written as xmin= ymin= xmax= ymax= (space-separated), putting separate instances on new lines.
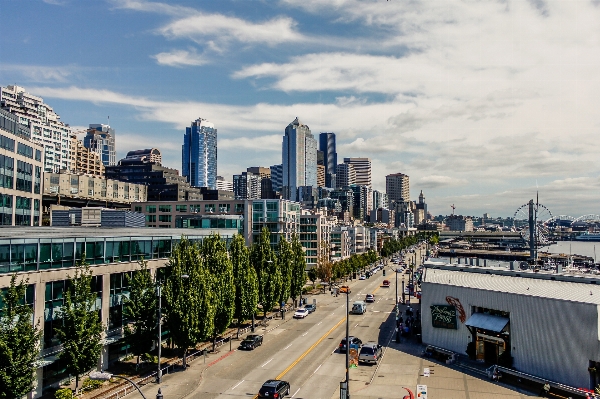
xmin=422 ymin=282 xmax=600 ymax=387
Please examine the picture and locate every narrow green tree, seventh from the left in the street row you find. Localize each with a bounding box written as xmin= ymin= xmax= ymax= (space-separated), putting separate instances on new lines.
xmin=250 ymin=228 xmax=281 ymax=316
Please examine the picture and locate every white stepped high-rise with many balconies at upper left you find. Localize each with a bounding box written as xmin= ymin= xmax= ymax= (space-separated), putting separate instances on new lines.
xmin=0 ymin=86 xmax=73 ymax=173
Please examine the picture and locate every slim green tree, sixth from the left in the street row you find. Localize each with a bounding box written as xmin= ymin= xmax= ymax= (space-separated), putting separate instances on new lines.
xmin=229 ymin=234 xmax=258 ymax=328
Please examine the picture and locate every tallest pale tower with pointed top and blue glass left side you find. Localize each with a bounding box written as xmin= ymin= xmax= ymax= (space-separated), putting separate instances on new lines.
xmin=282 ymin=118 xmax=317 ymax=201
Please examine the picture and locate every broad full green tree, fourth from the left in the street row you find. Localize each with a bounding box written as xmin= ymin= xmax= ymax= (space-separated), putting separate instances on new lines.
xmin=163 ymin=237 xmax=216 ymax=370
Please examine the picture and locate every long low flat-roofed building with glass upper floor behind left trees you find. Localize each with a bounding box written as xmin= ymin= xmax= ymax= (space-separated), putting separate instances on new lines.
xmin=0 ymin=227 xmax=236 ymax=398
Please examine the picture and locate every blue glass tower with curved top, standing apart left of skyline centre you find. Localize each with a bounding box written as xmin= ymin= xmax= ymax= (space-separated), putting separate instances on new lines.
xmin=181 ymin=118 xmax=217 ymax=190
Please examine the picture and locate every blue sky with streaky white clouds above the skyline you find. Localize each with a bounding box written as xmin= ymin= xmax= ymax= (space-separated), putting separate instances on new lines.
xmin=0 ymin=0 xmax=600 ymax=217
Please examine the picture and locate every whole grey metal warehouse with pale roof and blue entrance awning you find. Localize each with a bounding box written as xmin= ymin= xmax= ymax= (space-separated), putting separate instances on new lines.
xmin=421 ymin=263 xmax=600 ymax=388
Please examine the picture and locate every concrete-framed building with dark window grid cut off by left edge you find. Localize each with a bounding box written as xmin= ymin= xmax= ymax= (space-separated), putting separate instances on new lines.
xmin=0 ymin=110 xmax=44 ymax=226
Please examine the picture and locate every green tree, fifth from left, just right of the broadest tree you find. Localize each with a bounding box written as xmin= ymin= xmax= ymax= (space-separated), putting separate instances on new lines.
xmin=201 ymin=234 xmax=235 ymax=351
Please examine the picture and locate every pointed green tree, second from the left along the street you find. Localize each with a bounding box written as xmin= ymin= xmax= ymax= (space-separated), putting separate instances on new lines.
xmin=56 ymin=256 xmax=103 ymax=392
